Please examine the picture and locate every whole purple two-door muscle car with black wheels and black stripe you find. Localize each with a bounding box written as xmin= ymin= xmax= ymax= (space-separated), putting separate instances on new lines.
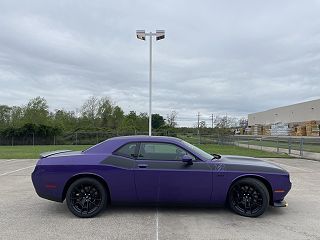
xmin=32 ymin=136 xmax=291 ymax=217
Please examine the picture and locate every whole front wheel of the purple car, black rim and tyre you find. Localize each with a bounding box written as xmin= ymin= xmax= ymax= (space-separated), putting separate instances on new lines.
xmin=228 ymin=178 xmax=269 ymax=217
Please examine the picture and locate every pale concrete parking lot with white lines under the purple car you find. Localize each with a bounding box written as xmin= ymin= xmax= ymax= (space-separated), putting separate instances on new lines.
xmin=0 ymin=159 xmax=320 ymax=239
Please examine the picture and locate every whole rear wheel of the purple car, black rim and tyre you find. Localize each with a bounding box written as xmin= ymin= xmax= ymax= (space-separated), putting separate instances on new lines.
xmin=66 ymin=177 xmax=107 ymax=218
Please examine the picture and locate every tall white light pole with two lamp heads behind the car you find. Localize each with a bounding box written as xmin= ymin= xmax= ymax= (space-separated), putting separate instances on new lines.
xmin=136 ymin=30 xmax=165 ymax=136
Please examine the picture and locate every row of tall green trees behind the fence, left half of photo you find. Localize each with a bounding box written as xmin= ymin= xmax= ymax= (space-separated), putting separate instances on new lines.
xmin=0 ymin=96 xmax=177 ymax=137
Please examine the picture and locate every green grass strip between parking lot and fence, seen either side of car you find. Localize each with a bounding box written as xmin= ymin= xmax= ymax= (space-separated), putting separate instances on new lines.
xmin=0 ymin=144 xmax=289 ymax=159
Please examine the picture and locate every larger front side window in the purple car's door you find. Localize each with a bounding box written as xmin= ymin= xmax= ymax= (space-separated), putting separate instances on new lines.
xmin=138 ymin=142 xmax=195 ymax=161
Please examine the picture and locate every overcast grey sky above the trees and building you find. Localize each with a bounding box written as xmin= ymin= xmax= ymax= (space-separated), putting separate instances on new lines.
xmin=0 ymin=0 xmax=320 ymax=126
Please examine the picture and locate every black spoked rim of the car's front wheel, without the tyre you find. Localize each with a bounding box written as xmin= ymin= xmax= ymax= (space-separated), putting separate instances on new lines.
xmin=231 ymin=183 xmax=263 ymax=214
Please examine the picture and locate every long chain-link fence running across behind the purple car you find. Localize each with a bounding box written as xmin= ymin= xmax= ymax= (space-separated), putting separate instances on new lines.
xmin=0 ymin=130 xmax=320 ymax=156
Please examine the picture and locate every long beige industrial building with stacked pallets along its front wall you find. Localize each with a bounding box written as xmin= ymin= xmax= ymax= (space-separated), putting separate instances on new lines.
xmin=246 ymin=99 xmax=320 ymax=136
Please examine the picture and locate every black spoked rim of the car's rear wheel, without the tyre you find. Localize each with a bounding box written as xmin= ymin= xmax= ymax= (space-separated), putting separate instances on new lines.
xmin=70 ymin=183 xmax=102 ymax=215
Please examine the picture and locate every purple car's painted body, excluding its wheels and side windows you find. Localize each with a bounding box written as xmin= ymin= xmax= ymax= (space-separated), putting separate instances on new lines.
xmin=32 ymin=136 xmax=291 ymax=205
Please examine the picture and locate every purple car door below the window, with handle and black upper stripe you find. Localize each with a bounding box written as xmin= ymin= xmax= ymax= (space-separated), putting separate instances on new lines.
xmin=135 ymin=160 xmax=212 ymax=203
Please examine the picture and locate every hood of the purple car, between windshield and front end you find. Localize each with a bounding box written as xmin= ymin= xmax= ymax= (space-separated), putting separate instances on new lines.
xmin=216 ymin=155 xmax=288 ymax=174
